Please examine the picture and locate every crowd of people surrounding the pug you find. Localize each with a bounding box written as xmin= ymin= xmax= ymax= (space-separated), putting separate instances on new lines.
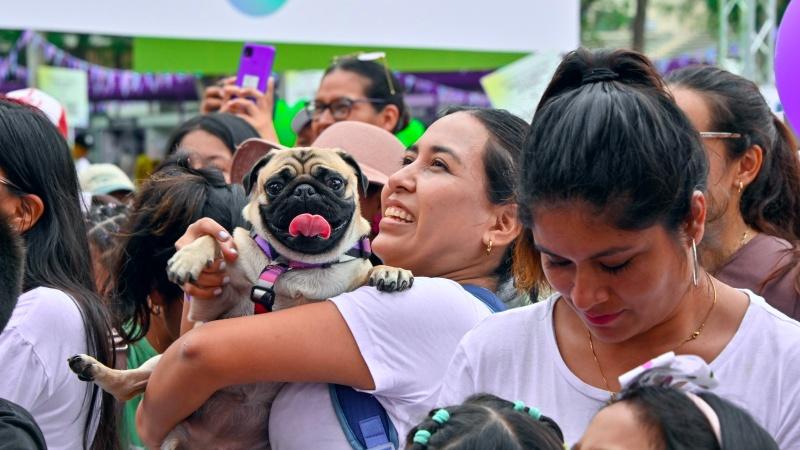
xmin=0 ymin=49 xmax=800 ymax=450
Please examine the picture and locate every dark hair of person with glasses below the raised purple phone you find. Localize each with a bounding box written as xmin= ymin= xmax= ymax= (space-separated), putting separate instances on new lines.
xmin=167 ymin=113 xmax=260 ymax=154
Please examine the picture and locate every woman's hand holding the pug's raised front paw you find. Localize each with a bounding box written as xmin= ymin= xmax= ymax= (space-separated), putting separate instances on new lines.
xmin=175 ymin=217 xmax=239 ymax=300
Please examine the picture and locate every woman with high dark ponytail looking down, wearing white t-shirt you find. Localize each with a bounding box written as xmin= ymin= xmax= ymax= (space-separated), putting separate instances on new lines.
xmin=439 ymin=49 xmax=800 ymax=448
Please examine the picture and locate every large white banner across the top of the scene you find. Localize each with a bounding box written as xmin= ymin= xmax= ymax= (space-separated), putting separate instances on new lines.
xmin=0 ymin=0 xmax=580 ymax=52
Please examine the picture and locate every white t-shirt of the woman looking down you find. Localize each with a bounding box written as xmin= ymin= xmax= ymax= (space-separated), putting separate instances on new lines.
xmin=438 ymin=291 xmax=800 ymax=449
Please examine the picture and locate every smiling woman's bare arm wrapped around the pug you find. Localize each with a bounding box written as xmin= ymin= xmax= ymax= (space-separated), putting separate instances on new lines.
xmin=137 ymin=301 xmax=374 ymax=447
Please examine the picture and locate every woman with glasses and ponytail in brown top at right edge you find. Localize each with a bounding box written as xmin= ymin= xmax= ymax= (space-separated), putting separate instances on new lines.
xmin=667 ymin=66 xmax=800 ymax=319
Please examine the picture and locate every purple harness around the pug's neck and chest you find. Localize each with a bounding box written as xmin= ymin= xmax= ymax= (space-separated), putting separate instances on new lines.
xmin=250 ymin=230 xmax=372 ymax=312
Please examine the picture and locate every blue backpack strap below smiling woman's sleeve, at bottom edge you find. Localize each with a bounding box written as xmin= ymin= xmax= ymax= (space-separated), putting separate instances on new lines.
xmin=328 ymin=384 xmax=400 ymax=450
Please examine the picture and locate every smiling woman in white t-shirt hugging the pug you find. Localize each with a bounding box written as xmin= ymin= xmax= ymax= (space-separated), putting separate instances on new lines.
xmin=139 ymin=106 xmax=527 ymax=449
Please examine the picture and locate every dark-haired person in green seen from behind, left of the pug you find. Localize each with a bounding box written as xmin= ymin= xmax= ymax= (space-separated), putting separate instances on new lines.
xmin=109 ymin=154 xmax=247 ymax=448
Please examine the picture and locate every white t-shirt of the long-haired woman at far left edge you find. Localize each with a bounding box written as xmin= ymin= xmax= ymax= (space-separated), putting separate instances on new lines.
xmin=0 ymin=287 xmax=97 ymax=450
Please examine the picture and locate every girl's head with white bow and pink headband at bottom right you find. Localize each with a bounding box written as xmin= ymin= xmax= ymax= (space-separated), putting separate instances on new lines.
xmin=573 ymin=353 xmax=778 ymax=450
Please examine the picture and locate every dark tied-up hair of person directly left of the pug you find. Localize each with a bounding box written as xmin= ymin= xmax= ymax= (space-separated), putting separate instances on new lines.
xmin=110 ymin=154 xmax=247 ymax=342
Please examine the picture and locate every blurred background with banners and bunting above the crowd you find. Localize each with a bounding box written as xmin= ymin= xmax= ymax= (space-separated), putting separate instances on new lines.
xmin=0 ymin=0 xmax=789 ymax=178
